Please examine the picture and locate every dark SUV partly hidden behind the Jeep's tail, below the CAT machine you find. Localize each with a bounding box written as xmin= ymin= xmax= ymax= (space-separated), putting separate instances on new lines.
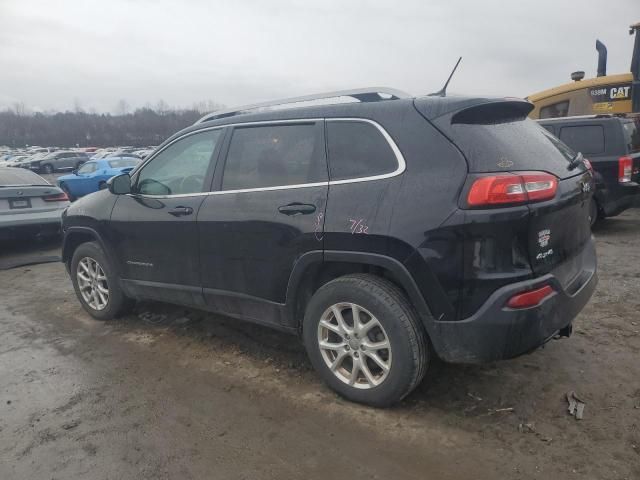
xmin=540 ymin=115 xmax=640 ymax=224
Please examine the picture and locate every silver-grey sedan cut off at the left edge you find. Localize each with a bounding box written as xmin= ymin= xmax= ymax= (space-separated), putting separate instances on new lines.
xmin=0 ymin=167 xmax=69 ymax=239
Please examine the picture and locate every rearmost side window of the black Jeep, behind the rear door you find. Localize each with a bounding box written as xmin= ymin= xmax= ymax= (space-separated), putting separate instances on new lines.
xmin=327 ymin=120 xmax=398 ymax=180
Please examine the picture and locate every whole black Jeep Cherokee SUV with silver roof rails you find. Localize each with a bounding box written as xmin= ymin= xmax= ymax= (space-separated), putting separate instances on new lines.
xmin=63 ymin=90 xmax=597 ymax=406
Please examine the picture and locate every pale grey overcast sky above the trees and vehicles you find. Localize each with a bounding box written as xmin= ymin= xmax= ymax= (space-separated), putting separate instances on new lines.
xmin=0 ymin=0 xmax=640 ymax=112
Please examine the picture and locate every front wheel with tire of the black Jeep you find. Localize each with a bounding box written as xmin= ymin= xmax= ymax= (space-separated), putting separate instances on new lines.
xmin=70 ymin=242 xmax=133 ymax=320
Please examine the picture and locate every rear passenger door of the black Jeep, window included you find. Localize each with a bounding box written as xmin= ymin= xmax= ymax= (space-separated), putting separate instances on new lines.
xmin=198 ymin=120 xmax=328 ymax=323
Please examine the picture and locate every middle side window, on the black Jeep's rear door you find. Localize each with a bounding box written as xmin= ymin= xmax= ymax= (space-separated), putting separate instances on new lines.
xmin=222 ymin=123 xmax=327 ymax=190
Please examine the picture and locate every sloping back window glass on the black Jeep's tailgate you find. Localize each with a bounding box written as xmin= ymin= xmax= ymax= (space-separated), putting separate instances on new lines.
xmin=447 ymin=118 xmax=580 ymax=178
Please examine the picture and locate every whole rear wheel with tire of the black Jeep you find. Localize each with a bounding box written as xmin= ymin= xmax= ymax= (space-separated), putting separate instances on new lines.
xmin=303 ymin=274 xmax=429 ymax=407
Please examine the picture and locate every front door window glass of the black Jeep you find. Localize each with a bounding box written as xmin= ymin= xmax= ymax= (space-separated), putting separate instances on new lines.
xmin=135 ymin=130 xmax=221 ymax=195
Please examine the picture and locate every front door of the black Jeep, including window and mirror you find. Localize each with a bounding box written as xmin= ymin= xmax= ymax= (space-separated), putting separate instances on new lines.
xmin=111 ymin=129 xmax=223 ymax=305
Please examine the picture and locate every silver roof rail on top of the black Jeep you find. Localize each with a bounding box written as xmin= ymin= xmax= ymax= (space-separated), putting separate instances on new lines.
xmin=196 ymin=87 xmax=411 ymax=124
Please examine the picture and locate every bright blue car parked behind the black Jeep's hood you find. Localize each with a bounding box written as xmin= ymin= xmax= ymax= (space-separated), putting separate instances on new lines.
xmin=58 ymin=157 xmax=141 ymax=200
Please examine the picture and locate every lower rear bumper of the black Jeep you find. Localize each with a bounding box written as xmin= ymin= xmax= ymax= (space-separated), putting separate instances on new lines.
xmin=429 ymin=241 xmax=598 ymax=363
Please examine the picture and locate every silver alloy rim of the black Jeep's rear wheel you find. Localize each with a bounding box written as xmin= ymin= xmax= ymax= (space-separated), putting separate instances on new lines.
xmin=318 ymin=303 xmax=391 ymax=389
